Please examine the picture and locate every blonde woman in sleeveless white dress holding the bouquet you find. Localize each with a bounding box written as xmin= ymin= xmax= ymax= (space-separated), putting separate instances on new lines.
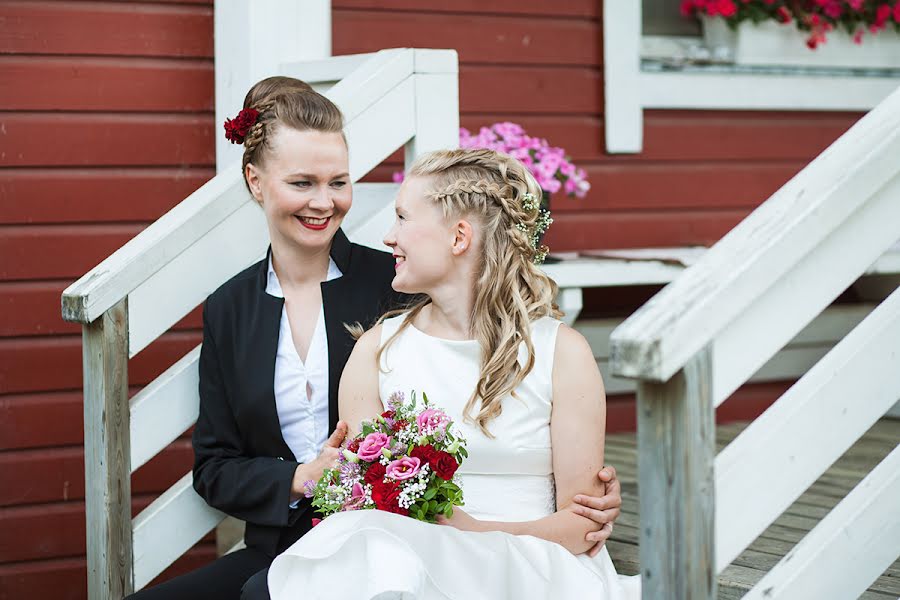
xmin=269 ymin=150 xmax=639 ymax=600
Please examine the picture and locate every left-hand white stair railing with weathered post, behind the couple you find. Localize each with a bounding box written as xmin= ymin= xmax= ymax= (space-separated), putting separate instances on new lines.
xmin=62 ymin=49 xmax=459 ymax=599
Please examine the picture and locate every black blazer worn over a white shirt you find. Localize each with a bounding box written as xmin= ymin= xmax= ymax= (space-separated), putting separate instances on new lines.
xmin=193 ymin=230 xmax=407 ymax=556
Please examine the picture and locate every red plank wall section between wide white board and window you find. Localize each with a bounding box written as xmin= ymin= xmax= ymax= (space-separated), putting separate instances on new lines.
xmin=333 ymin=0 xmax=860 ymax=251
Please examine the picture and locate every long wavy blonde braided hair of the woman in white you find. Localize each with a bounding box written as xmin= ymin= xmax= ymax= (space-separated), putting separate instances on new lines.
xmin=378 ymin=149 xmax=562 ymax=437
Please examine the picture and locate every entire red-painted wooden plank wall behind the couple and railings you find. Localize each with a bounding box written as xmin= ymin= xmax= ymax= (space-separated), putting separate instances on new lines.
xmin=0 ymin=0 xmax=858 ymax=600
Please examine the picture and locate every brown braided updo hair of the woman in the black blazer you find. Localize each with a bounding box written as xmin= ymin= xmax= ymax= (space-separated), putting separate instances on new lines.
xmin=241 ymin=76 xmax=347 ymax=189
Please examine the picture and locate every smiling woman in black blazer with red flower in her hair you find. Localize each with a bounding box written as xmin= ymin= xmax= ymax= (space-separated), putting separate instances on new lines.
xmin=126 ymin=77 xmax=621 ymax=600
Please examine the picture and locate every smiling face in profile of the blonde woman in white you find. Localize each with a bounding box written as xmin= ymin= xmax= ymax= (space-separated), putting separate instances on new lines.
xmin=384 ymin=177 xmax=459 ymax=294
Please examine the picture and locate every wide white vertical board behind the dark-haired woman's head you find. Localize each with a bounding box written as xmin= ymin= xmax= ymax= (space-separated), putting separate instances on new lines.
xmin=214 ymin=0 xmax=331 ymax=172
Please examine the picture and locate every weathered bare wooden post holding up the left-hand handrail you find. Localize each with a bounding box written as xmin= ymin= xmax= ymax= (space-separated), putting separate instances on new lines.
xmin=82 ymin=298 xmax=134 ymax=600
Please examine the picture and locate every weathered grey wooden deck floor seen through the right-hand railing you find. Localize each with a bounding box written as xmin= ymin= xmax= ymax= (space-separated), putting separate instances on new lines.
xmin=606 ymin=419 xmax=900 ymax=600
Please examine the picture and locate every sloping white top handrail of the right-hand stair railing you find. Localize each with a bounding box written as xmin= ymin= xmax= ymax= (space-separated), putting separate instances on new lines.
xmin=611 ymin=82 xmax=900 ymax=382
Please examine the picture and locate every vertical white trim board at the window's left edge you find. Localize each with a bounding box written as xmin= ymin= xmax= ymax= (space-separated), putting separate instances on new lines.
xmin=603 ymin=0 xmax=644 ymax=154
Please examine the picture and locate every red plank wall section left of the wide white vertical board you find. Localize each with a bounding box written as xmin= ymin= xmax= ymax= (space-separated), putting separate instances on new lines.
xmin=0 ymin=0 xmax=218 ymax=600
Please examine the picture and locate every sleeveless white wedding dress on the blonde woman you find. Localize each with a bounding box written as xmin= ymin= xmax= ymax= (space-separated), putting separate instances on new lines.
xmin=268 ymin=316 xmax=640 ymax=600
